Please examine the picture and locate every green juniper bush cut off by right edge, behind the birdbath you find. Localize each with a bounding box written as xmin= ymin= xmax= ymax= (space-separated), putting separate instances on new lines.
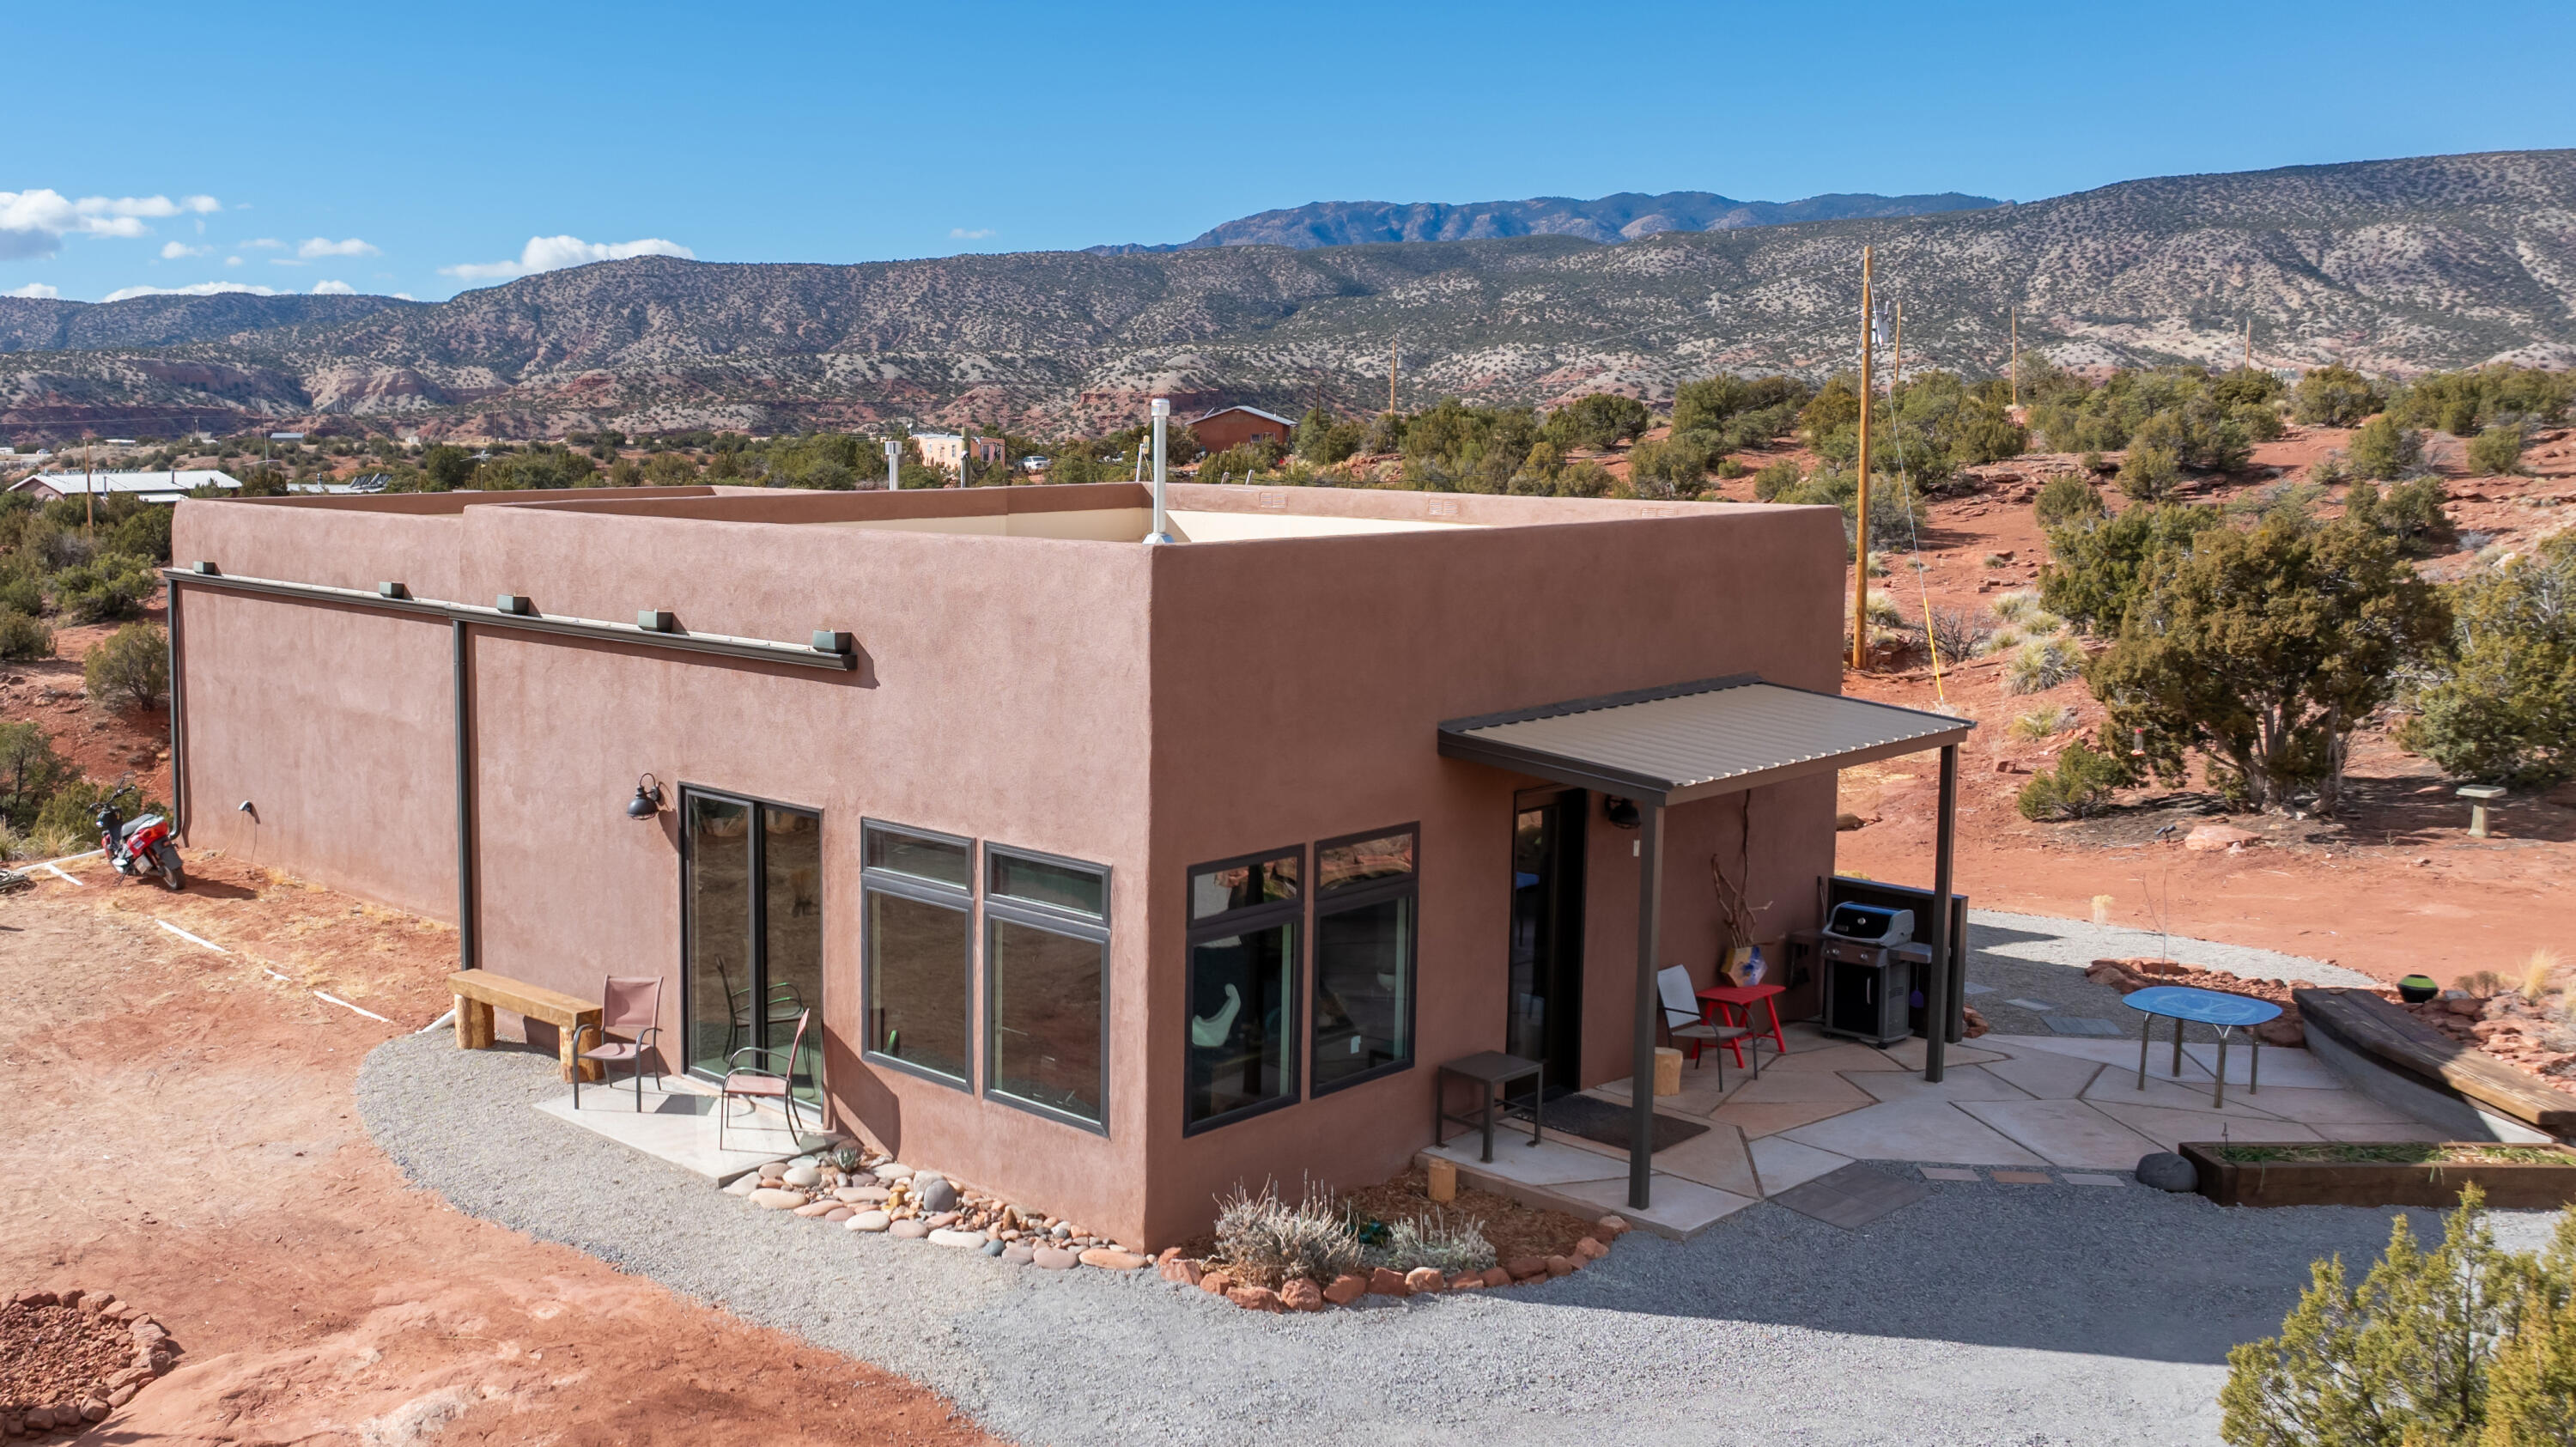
xmin=2403 ymin=533 xmax=2576 ymax=785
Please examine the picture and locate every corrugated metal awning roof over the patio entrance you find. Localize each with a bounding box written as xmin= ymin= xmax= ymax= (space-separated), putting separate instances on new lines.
xmin=1440 ymin=675 xmax=1976 ymax=803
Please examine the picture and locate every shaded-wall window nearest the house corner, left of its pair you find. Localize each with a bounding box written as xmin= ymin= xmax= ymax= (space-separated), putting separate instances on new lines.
xmin=1182 ymin=849 xmax=1306 ymax=1133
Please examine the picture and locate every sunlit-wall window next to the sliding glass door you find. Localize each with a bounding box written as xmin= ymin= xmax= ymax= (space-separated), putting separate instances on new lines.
xmin=860 ymin=821 xmax=974 ymax=1086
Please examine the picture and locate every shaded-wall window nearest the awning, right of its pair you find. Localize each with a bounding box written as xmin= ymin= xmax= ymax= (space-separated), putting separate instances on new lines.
xmin=1314 ymin=824 xmax=1422 ymax=1094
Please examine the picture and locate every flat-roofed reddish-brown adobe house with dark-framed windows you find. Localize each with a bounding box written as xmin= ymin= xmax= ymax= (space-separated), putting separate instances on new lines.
xmin=170 ymin=473 xmax=1965 ymax=1246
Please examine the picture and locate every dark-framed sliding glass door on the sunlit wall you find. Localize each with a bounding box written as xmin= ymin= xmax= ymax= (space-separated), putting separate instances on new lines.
xmin=680 ymin=787 xmax=822 ymax=1099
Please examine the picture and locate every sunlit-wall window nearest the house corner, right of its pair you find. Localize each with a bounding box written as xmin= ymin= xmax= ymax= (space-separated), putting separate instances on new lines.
xmin=984 ymin=844 xmax=1110 ymax=1130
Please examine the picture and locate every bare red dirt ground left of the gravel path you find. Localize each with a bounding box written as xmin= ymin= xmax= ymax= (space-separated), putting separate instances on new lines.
xmin=0 ymin=854 xmax=989 ymax=1447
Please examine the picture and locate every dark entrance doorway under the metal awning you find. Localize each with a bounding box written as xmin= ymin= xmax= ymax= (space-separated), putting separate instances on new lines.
xmin=1504 ymin=787 xmax=1592 ymax=1097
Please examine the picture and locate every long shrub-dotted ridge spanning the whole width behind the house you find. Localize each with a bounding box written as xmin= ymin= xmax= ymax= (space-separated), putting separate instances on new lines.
xmin=0 ymin=149 xmax=2576 ymax=443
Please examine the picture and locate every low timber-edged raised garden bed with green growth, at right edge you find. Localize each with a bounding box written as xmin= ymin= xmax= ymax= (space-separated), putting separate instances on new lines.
xmin=2182 ymin=1140 xmax=2576 ymax=1210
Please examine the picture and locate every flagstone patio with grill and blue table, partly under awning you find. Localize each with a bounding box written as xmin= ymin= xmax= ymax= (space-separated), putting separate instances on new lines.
xmin=1427 ymin=1024 xmax=2442 ymax=1238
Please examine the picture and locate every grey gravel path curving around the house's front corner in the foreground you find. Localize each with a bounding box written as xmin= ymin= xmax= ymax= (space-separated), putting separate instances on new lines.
xmin=358 ymin=1032 xmax=2548 ymax=1447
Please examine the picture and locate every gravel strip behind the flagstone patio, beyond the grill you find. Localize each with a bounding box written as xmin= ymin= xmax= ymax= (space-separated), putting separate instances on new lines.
xmin=1968 ymin=909 xmax=2378 ymax=1040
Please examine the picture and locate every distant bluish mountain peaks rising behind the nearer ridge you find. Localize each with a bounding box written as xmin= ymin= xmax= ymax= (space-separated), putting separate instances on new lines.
xmin=1090 ymin=191 xmax=2002 ymax=255
